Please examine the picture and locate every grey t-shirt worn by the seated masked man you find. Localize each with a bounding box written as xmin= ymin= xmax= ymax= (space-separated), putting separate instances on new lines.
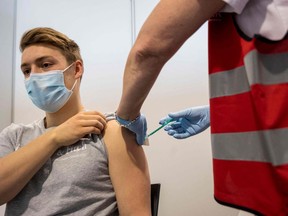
xmin=0 ymin=120 xmax=119 ymax=216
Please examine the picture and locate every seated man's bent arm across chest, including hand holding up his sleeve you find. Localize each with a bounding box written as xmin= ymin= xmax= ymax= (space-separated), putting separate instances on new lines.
xmin=0 ymin=111 xmax=105 ymax=205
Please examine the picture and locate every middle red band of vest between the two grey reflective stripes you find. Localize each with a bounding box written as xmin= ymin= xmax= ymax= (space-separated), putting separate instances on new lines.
xmin=210 ymin=83 xmax=288 ymax=133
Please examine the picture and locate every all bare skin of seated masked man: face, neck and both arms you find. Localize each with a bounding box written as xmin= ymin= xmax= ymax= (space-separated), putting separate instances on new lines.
xmin=0 ymin=44 xmax=151 ymax=215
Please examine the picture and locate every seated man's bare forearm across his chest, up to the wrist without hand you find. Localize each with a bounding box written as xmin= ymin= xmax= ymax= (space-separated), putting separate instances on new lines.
xmin=0 ymin=133 xmax=58 ymax=205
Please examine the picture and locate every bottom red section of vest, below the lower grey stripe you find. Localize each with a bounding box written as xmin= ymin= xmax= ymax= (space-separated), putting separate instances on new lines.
xmin=213 ymin=159 xmax=288 ymax=216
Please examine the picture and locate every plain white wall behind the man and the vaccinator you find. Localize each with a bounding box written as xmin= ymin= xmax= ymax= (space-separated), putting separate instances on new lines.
xmin=0 ymin=0 xmax=238 ymax=216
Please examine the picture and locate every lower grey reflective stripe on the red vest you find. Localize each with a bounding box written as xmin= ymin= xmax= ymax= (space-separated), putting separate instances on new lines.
xmin=211 ymin=128 xmax=288 ymax=165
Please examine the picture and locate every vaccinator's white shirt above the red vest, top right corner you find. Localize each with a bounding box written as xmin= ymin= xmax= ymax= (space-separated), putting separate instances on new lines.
xmin=221 ymin=0 xmax=288 ymax=41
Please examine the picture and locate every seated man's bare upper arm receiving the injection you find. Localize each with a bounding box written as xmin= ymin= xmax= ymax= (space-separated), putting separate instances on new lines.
xmin=104 ymin=121 xmax=151 ymax=216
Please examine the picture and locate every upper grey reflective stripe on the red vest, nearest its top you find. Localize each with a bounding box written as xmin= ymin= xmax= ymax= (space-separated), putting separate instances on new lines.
xmin=209 ymin=50 xmax=288 ymax=98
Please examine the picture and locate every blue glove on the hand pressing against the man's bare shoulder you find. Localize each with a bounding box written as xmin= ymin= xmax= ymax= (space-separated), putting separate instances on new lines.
xmin=115 ymin=114 xmax=147 ymax=145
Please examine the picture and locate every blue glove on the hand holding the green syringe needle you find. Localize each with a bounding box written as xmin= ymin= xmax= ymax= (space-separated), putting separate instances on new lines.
xmin=159 ymin=106 xmax=210 ymax=139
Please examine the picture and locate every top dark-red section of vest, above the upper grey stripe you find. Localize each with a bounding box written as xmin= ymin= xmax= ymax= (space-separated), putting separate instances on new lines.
xmin=208 ymin=14 xmax=288 ymax=74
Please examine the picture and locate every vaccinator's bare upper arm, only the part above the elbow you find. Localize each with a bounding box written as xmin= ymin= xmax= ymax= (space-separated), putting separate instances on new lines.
xmin=135 ymin=0 xmax=225 ymax=58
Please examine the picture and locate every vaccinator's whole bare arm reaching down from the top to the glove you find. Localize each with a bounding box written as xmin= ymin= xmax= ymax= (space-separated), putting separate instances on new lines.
xmin=117 ymin=0 xmax=225 ymax=120
